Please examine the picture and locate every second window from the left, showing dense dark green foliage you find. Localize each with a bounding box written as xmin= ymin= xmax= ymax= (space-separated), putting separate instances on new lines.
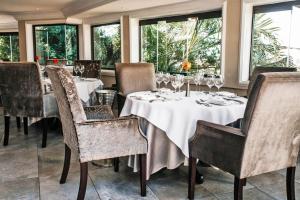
xmin=33 ymin=24 xmax=78 ymax=65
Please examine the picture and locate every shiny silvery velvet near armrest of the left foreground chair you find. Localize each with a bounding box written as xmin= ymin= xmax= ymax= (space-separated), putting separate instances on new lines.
xmin=75 ymin=117 xmax=147 ymax=162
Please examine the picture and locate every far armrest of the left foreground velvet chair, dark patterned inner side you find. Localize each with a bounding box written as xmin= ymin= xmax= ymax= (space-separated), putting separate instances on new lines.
xmin=84 ymin=105 xmax=115 ymax=120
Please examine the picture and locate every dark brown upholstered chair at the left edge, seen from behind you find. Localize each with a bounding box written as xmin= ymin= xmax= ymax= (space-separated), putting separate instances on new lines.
xmin=0 ymin=62 xmax=59 ymax=147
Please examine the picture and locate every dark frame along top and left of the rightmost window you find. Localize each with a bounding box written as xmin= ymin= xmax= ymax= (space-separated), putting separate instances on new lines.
xmin=248 ymin=0 xmax=300 ymax=74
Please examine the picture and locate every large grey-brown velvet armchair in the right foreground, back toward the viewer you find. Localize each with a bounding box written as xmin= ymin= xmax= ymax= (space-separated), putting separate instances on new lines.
xmin=188 ymin=72 xmax=300 ymax=200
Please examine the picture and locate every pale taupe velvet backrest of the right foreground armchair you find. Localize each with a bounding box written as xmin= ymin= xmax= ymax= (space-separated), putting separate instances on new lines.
xmin=241 ymin=72 xmax=300 ymax=177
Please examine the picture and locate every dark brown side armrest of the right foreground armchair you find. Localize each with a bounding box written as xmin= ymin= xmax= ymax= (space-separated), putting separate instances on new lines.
xmin=189 ymin=121 xmax=246 ymax=175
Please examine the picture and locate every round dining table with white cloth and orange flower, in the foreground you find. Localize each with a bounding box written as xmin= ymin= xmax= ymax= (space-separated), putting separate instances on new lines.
xmin=120 ymin=89 xmax=247 ymax=179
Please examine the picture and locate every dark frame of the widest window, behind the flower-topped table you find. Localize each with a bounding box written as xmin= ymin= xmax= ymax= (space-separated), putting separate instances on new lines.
xmin=139 ymin=9 xmax=223 ymax=71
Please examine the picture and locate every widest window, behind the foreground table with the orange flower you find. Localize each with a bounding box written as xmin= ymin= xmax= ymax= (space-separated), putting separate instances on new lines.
xmin=140 ymin=11 xmax=222 ymax=73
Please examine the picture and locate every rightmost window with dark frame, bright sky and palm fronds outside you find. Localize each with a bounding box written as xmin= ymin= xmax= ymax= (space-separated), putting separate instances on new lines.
xmin=250 ymin=1 xmax=300 ymax=71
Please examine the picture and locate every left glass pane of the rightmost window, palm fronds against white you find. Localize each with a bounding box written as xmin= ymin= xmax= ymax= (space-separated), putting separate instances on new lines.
xmin=251 ymin=10 xmax=291 ymax=70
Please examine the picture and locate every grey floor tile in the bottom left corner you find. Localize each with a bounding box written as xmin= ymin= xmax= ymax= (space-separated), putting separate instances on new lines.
xmin=0 ymin=178 xmax=39 ymax=200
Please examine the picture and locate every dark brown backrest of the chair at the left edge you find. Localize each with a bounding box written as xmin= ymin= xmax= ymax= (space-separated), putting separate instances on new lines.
xmin=0 ymin=62 xmax=44 ymax=117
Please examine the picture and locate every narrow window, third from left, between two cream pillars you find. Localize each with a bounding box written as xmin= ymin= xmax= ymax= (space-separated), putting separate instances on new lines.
xmin=92 ymin=23 xmax=121 ymax=69
